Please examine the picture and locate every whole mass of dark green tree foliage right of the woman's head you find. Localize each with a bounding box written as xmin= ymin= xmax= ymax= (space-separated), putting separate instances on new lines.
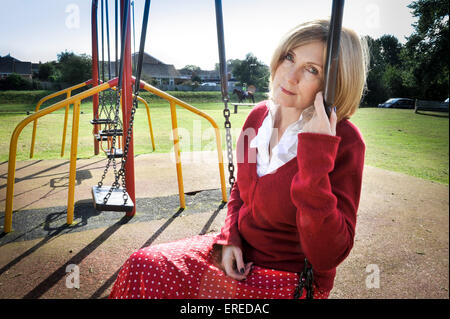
xmin=364 ymin=0 xmax=449 ymax=105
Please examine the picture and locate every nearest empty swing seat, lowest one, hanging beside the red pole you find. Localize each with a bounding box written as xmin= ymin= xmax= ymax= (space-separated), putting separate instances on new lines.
xmin=92 ymin=186 xmax=134 ymax=212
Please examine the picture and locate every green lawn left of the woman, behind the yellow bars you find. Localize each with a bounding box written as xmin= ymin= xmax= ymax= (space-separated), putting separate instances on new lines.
xmin=0 ymin=101 xmax=251 ymax=162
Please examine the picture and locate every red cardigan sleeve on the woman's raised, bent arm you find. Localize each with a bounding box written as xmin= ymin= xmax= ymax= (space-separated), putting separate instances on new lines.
xmin=291 ymin=133 xmax=365 ymax=271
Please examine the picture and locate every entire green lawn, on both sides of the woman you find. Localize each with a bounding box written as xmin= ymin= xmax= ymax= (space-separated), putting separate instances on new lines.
xmin=0 ymin=101 xmax=449 ymax=185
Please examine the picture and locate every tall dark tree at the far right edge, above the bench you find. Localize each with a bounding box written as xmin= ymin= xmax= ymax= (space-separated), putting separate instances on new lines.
xmin=406 ymin=0 xmax=449 ymax=100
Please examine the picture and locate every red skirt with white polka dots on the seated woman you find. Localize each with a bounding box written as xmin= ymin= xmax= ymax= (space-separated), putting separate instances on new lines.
xmin=109 ymin=235 xmax=329 ymax=299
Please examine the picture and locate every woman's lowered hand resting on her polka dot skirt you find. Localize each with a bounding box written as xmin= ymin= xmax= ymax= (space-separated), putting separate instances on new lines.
xmin=222 ymin=245 xmax=253 ymax=280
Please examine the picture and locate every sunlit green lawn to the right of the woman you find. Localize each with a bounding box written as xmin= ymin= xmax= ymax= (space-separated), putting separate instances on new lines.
xmin=352 ymin=108 xmax=449 ymax=185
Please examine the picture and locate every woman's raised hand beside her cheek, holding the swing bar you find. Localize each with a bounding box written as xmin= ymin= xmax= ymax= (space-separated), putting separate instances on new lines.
xmin=303 ymin=92 xmax=337 ymax=136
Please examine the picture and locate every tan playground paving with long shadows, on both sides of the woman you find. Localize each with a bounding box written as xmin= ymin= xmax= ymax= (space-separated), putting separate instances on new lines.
xmin=0 ymin=152 xmax=449 ymax=299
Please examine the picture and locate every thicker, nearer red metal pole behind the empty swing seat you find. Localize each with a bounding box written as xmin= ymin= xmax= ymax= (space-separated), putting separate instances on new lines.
xmin=121 ymin=0 xmax=136 ymax=216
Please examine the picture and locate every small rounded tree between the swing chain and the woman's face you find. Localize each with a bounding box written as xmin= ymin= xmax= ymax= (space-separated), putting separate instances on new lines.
xmin=232 ymin=53 xmax=270 ymax=91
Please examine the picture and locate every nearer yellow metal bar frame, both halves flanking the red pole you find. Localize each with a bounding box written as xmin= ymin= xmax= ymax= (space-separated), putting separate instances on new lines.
xmin=4 ymin=81 xmax=227 ymax=233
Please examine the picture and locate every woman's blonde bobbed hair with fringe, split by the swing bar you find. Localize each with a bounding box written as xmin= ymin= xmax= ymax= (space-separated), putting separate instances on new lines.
xmin=269 ymin=20 xmax=369 ymax=121
